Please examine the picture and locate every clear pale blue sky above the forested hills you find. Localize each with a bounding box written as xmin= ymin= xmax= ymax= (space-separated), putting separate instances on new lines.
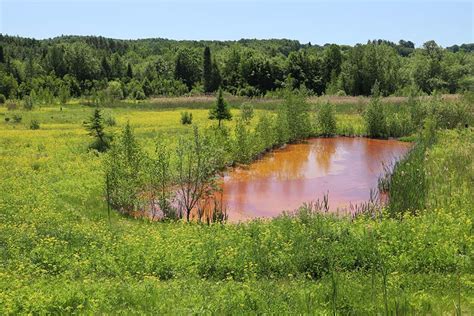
xmin=0 ymin=0 xmax=474 ymax=46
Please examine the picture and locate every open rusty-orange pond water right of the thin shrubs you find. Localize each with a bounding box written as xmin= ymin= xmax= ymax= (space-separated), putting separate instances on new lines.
xmin=222 ymin=137 xmax=410 ymax=221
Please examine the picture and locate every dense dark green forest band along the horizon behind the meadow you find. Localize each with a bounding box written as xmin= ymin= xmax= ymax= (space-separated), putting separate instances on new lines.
xmin=0 ymin=34 xmax=474 ymax=102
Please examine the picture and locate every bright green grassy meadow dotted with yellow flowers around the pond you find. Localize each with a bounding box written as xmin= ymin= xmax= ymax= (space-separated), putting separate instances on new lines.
xmin=0 ymin=99 xmax=474 ymax=315
